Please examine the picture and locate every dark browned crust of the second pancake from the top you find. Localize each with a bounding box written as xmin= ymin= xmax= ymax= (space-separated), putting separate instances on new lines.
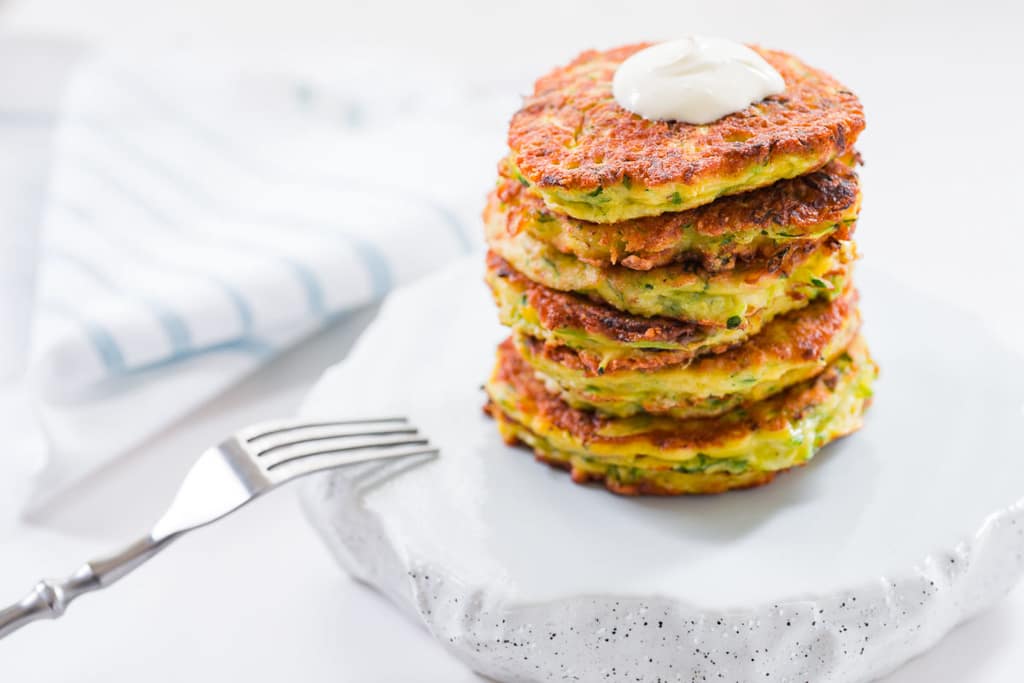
xmin=495 ymin=161 xmax=860 ymax=272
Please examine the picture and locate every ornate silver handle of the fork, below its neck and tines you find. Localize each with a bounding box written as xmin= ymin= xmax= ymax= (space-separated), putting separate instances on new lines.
xmin=0 ymin=536 xmax=173 ymax=638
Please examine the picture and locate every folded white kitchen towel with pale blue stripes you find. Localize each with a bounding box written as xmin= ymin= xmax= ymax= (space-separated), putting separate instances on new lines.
xmin=14 ymin=48 xmax=514 ymax=507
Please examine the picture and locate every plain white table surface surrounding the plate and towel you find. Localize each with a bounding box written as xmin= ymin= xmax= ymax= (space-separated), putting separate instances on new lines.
xmin=0 ymin=0 xmax=1024 ymax=683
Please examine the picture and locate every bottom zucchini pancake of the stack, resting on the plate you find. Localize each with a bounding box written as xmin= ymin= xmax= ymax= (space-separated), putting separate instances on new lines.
xmin=487 ymin=338 xmax=877 ymax=494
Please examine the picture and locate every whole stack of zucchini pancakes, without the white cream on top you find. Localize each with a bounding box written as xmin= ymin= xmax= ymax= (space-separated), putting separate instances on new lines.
xmin=483 ymin=45 xmax=878 ymax=495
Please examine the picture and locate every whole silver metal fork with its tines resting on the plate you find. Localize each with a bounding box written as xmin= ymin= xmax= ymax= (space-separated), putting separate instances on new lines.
xmin=0 ymin=418 xmax=437 ymax=638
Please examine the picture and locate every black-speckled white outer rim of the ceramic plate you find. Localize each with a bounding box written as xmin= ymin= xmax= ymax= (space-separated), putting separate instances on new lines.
xmin=302 ymin=258 xmax=1024 ymax=682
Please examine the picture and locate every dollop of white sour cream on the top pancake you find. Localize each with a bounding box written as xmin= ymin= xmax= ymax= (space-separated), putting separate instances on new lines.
xmin=611 ymin=36 xmax=785 ymax=124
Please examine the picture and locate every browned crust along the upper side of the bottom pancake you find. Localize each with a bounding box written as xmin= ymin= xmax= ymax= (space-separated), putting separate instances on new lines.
xmin=495 ymin=338 xmax=851 ymax=451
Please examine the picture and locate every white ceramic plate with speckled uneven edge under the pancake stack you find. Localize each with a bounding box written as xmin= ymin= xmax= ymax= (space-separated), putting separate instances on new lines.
xmin=296 ymin=259 xmax=1024 ymax=682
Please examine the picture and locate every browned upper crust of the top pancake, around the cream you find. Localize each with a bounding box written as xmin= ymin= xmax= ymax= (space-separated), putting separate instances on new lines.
xmin=508 ymin=43 xmax=864 ymax=190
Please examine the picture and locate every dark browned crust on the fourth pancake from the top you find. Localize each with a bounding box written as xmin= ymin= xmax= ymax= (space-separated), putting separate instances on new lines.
xmin=487 ymin=252 xmax=708 ymax=344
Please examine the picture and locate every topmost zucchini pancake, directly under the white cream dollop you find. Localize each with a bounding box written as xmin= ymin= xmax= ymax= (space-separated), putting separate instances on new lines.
xmin=508 ymin=43 xmax=864 ymax=223
